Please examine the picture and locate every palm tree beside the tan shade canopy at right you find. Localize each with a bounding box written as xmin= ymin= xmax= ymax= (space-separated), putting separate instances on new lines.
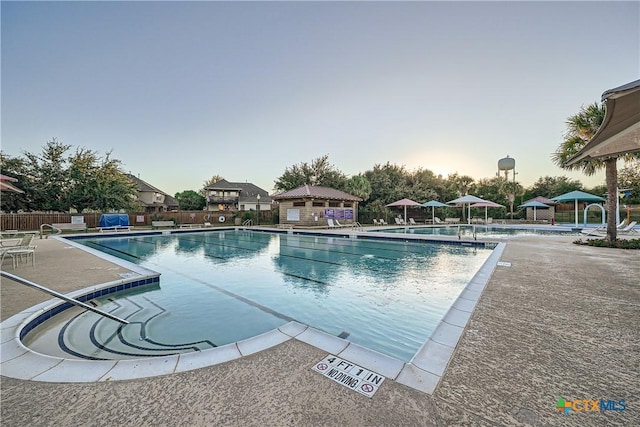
xmin=551 ymin=102 xmax=618 ymax=242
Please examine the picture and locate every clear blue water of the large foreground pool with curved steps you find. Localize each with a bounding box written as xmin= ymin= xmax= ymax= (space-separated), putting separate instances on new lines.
xmin=25 ymin=230 xmax=491 ymax=361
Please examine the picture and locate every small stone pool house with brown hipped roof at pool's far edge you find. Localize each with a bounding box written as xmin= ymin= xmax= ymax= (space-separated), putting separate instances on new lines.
xmin=272 ymin=185 xmax=362 ymax=227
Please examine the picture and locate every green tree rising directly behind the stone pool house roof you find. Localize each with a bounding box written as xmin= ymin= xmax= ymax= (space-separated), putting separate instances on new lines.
xmin=274 ymin=154 xmax=347 ymax=191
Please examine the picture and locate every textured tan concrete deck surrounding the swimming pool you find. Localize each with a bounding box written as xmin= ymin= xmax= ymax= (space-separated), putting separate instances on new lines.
xmin=0 ymin=232 xmax=640 ymax=426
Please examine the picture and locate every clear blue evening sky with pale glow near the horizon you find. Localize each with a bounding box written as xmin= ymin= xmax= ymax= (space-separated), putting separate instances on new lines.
xmin=0 ymin=1 xmax=640 ymax=197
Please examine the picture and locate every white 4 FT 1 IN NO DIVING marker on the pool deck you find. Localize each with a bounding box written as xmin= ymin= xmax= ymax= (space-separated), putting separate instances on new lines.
xmin=312 ymin=354 xmax=384 ymax=397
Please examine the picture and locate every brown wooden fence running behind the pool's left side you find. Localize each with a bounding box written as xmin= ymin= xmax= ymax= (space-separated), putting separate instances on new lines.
xmin=0 ymin=211 xmax=272 ymax=231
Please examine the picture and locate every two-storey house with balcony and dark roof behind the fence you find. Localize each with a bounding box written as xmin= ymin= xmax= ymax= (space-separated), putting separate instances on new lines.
xmin=204 ymin=179 xmax=271 ymax=212
